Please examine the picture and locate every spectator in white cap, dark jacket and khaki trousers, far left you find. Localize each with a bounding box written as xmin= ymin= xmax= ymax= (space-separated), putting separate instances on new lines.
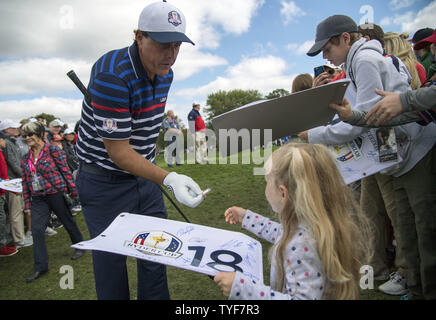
xmin=0 ymin=119 xmax=33 ymax=247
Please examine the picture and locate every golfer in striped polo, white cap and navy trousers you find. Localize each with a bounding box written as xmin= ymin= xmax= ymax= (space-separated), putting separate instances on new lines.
xmin=77 ymin=1 xmax=203 ymax=299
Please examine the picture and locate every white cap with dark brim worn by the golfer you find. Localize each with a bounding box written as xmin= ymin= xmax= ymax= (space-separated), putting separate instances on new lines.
xmin=138 ymin=0 xmax=195 ymax=45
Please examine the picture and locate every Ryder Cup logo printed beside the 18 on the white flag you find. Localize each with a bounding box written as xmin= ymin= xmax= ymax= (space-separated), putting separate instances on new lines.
xmin=124 ymin=231 xmax=182 ymax=258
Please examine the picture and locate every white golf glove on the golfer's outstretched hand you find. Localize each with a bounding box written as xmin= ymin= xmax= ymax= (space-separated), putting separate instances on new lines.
xmin=163 ymin=172 xmax=204 ymax=208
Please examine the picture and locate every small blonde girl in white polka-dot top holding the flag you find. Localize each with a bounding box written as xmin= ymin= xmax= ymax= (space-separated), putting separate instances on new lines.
xmin=214 ymin=144 xmax=368 ymax=300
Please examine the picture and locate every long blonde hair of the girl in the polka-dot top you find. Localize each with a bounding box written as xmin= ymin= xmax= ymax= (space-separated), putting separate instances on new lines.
xmin=267 ymin=143 xmax=370 ymax=299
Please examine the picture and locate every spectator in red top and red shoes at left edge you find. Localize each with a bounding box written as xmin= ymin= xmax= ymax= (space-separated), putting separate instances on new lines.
xmin=0 ymin=132 xmax=18 ymax=258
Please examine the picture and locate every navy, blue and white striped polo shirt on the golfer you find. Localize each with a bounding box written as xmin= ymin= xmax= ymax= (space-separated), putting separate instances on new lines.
xmin=77 ymin=42 xmax=173 ymax=172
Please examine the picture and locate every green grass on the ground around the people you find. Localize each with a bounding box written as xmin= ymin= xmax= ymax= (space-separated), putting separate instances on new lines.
xmin=0 ymin=150 xmax=399 ymax=300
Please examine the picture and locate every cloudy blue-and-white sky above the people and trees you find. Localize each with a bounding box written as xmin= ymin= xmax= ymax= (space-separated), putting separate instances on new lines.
xmin=0 ymin=0 xmax=436 ymax=126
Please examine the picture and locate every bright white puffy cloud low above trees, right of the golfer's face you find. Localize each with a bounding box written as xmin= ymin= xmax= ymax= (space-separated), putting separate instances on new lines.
xmin=174 ymin=55 xmax=292 ymax=100
